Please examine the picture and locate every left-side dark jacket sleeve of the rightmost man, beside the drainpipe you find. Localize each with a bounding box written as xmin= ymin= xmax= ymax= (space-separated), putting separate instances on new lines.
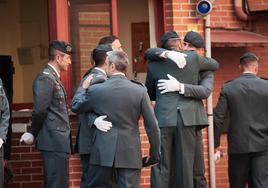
xmin=213 ymin=87 xmax=229 ymax=148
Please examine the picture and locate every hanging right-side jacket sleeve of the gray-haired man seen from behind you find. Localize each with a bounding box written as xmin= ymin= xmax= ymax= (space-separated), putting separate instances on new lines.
xmin=141 ymin=89 xmax=160 ymax=161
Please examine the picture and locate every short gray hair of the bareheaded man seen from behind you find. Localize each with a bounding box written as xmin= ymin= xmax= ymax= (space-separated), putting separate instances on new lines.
xmin=107 ymin=51 xmax=129 ymax=72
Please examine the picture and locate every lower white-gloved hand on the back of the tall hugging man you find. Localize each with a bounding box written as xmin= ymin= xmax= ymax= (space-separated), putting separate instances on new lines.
xmin=157 ymin=74 xmax=181 ymax=94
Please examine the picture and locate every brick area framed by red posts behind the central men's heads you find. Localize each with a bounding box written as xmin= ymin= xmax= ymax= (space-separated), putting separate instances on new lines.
xmin=70 ymin=2 xmax=111 ymax=86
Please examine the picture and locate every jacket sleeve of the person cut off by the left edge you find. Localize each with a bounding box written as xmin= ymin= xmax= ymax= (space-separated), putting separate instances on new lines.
xmin=0 ymin=80 xmax=10 ymax=140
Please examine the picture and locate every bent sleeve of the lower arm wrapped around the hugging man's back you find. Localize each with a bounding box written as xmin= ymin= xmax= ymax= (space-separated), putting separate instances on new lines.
xmin=184 ymin=71 xmax=214 ymax=99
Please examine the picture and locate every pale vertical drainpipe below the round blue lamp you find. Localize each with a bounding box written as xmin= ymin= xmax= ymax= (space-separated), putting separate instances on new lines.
xmin=205 ymin=14 xmax=216 ymax=188
